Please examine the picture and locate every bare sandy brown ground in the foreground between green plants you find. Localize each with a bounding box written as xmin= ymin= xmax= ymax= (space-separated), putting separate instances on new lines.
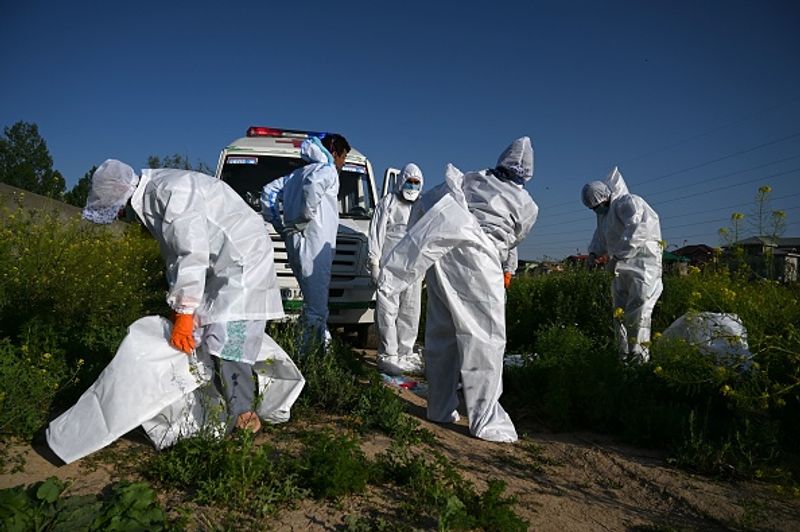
xmin=0 ymin=352 xmax=800 ymax=532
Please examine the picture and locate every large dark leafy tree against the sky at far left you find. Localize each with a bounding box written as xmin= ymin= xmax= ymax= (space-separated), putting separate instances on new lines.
xmin=0 ymin=121 xmax=65 ymax=199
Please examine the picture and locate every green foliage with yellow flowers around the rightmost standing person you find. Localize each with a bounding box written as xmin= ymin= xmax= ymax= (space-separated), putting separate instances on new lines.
xmin=504 ymin=268 xmax=800 ymax=478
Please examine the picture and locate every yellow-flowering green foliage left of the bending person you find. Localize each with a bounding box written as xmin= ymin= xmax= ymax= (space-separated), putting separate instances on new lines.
xmin=0 ymin=207 xmax=164 ymax=437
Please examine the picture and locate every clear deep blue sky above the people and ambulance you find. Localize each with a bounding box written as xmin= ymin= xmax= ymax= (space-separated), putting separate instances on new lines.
xmin=0 ymin=0 xmax=800 ymax=259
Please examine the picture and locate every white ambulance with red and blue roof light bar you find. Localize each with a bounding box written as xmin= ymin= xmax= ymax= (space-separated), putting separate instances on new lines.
xmin=216 ymin=126 xmax=377 ymax=346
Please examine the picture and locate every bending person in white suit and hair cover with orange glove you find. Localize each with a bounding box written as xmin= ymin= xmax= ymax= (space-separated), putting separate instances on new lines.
xmin=83 ymin=159 xmax=284 ymax=432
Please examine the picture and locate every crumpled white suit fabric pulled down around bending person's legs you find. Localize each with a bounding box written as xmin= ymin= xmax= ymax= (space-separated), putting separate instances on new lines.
xmin=47 ymin=316 xmax=305 ymax=463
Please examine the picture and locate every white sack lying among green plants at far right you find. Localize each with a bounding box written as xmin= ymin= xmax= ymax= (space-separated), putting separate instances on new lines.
xmin=663 ymin=312 xmax=753 ymax=367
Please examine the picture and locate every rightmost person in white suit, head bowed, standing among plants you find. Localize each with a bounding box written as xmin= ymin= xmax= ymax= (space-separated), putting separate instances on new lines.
xmin=581 ymin=167 xmax=663 ymax=363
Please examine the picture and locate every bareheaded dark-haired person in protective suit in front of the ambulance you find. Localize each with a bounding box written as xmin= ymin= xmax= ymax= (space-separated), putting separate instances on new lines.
xmin=261 ymin=134 xmax=350 ymax=354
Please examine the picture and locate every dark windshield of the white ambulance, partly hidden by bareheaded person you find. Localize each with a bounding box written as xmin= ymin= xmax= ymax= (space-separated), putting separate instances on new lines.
xmin=220 ymin=155 xmax=374 ymax=218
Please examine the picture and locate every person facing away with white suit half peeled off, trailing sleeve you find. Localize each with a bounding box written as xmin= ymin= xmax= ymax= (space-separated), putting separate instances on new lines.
xmin=378 ymin=137 xmax=539 ymax=442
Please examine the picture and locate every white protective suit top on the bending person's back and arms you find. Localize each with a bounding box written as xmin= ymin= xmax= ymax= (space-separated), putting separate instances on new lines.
xmin=131 ymin=168 xmax=284 ymax=324
